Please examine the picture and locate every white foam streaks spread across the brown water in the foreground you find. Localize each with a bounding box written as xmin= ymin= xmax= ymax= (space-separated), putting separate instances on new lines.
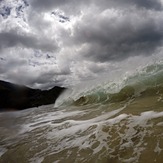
xmin=0 ymin=102 xmax=163 ymax=163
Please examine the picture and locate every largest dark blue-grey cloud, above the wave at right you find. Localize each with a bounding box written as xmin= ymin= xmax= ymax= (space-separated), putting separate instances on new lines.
xmin=74 ymin=9 xmax=163 ymax=62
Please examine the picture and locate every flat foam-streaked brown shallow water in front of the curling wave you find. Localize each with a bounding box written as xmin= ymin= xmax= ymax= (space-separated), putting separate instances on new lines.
xmin=0 ymin=93 xmax=163 ymax=163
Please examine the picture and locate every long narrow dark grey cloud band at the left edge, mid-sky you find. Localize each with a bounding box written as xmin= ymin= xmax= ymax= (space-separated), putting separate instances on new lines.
xmin=0 ymin=30 xmax=58 ymax=51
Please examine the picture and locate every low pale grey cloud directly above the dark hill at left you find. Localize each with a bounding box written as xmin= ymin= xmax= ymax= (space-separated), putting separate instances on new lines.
xmin=0 ymin=61 xmax=69 ymax=89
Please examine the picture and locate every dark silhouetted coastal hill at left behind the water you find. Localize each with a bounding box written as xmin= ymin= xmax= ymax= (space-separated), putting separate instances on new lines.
xmin=0 ymin=80 xmax=65 ymax=111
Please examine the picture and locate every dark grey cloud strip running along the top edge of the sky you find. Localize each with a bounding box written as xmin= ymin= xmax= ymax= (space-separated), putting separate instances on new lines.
xmin=30 ymin=0 xmax=162 ymax=14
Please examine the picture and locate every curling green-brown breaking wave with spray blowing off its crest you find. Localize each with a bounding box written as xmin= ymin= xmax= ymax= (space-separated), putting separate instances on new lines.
xmin=57 ymin=62 xmax=163 ymax=106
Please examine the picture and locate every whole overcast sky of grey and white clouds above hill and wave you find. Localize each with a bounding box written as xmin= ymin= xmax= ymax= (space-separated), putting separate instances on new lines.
xmin=0 ymin=0 xmax=163 ymax=89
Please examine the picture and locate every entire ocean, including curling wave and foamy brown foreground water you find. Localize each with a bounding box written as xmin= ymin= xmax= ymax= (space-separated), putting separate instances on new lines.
xmin=0 ymin=62 xmax=163 ymax=163
